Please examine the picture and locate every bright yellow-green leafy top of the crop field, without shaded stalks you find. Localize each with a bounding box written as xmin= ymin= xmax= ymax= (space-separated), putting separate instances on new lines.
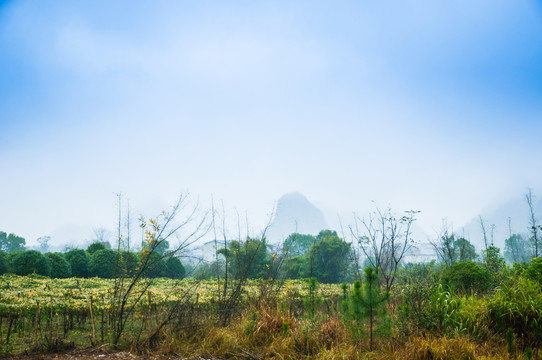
xmin=0 ymin=275 xmax=341 ymax=315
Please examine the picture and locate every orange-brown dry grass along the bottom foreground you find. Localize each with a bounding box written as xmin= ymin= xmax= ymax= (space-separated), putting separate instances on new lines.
xmin=117 ymin=306 xmax=542 ymax=360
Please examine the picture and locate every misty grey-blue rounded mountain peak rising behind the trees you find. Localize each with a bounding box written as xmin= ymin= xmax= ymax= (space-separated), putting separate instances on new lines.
xmin=266 ymin=192 xmax=327 ymax=244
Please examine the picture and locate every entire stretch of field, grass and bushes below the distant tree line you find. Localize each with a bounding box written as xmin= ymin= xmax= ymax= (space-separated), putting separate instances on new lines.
xmin=0 ymin=270 xmax=542 ymax=360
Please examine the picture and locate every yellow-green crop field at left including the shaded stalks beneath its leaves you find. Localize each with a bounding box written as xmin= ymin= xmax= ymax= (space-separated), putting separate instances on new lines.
xmin=0 ymin=275 xmax=341 ymax=353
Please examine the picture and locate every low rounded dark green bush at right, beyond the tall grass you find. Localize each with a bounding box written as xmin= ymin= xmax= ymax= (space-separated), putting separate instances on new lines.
xmin=446 ymin=261 xmax=493 ymax=292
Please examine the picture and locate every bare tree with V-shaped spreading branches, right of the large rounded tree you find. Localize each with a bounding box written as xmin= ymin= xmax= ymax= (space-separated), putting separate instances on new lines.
xmin=350 ymin=208 xmax=419 ymax=291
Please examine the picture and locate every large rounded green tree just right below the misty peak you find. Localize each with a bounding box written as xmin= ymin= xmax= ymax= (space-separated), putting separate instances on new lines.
xmin=309 ymin=230 xmax=350 ymax=284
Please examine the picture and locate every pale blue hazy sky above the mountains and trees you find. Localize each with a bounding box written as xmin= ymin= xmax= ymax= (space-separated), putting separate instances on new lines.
xmin=0 ymin=0 xmax=542 ymax=248
